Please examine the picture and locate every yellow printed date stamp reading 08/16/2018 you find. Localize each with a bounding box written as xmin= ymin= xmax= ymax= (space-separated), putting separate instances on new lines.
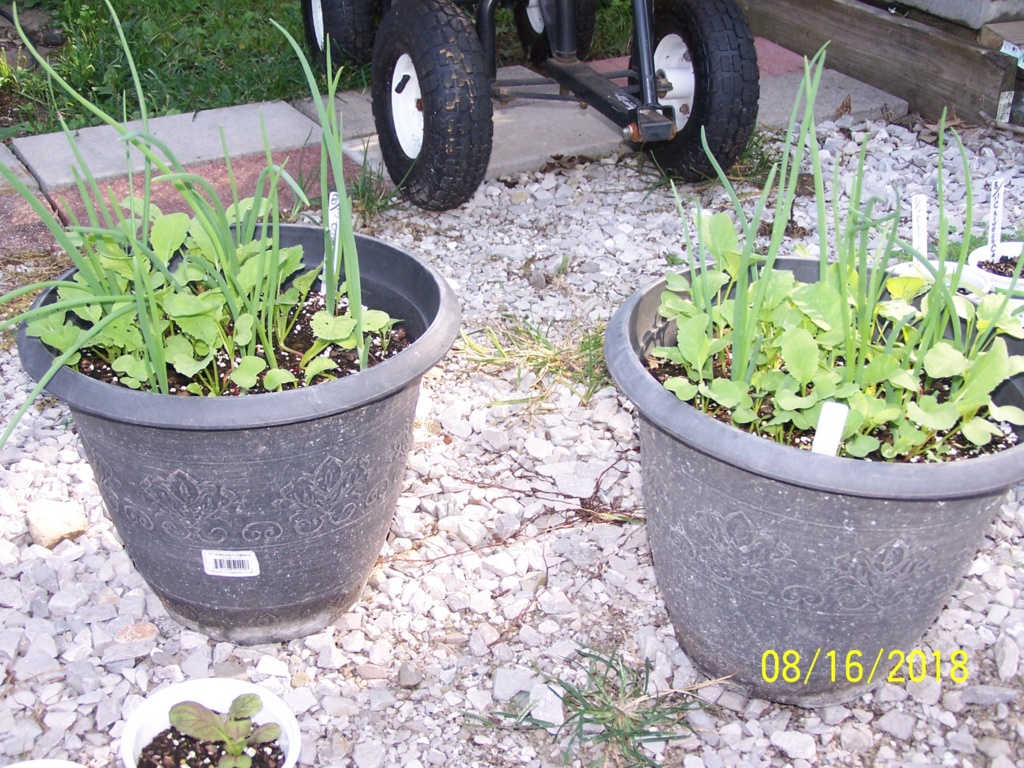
xmin=761 ymin=648 xmax=968 ymax=685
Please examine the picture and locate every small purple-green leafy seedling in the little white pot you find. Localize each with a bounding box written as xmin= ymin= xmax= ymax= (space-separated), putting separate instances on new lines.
xmin=170 ymin=693 xmax=281 ymax=768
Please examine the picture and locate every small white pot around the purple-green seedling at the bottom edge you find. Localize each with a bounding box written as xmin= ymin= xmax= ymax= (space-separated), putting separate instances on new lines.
xmin=120 ymin=677 xmax=302 ymax=768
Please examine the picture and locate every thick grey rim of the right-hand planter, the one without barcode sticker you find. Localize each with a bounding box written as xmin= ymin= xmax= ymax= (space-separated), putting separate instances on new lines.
xmin=604 ymin=258 xmax=1024 ymax=500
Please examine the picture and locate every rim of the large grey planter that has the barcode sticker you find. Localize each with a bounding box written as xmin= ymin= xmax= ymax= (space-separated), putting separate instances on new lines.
xmin=17 ymin=224 xmax=461 ymax=430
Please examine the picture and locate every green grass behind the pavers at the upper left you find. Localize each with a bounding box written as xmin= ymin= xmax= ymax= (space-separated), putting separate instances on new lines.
xmin=0 ymin=0 xmax=368 ymax=138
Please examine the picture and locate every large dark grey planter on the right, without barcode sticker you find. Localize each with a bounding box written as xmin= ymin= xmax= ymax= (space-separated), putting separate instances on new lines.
xmin=605 ymin=259 xmax=1024 ymax=707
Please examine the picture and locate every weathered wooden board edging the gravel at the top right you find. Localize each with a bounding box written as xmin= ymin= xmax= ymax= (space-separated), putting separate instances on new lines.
xmin=740 ymin=0 xmax=1017 ymax=123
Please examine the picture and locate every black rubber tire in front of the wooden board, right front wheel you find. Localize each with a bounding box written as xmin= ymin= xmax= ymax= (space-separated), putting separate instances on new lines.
xmin=630 ymin=0 xmax=761 ymax=181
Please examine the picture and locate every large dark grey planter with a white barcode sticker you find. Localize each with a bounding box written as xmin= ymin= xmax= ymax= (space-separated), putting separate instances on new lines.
xmin=18 ymin=226 xmax=460 ymax=643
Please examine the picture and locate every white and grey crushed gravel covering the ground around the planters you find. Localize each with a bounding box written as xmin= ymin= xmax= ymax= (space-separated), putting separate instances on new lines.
xmin=0 ymin=115 xmax=1024 ymax=768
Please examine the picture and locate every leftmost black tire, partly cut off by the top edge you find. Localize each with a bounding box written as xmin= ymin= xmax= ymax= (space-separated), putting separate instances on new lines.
xmin=302 ymin=0 xmax=380 ymax=69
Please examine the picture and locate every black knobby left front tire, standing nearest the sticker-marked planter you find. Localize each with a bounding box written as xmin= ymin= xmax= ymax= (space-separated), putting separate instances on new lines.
xmin=371 ymin=0 xmax=494 ymax=211
